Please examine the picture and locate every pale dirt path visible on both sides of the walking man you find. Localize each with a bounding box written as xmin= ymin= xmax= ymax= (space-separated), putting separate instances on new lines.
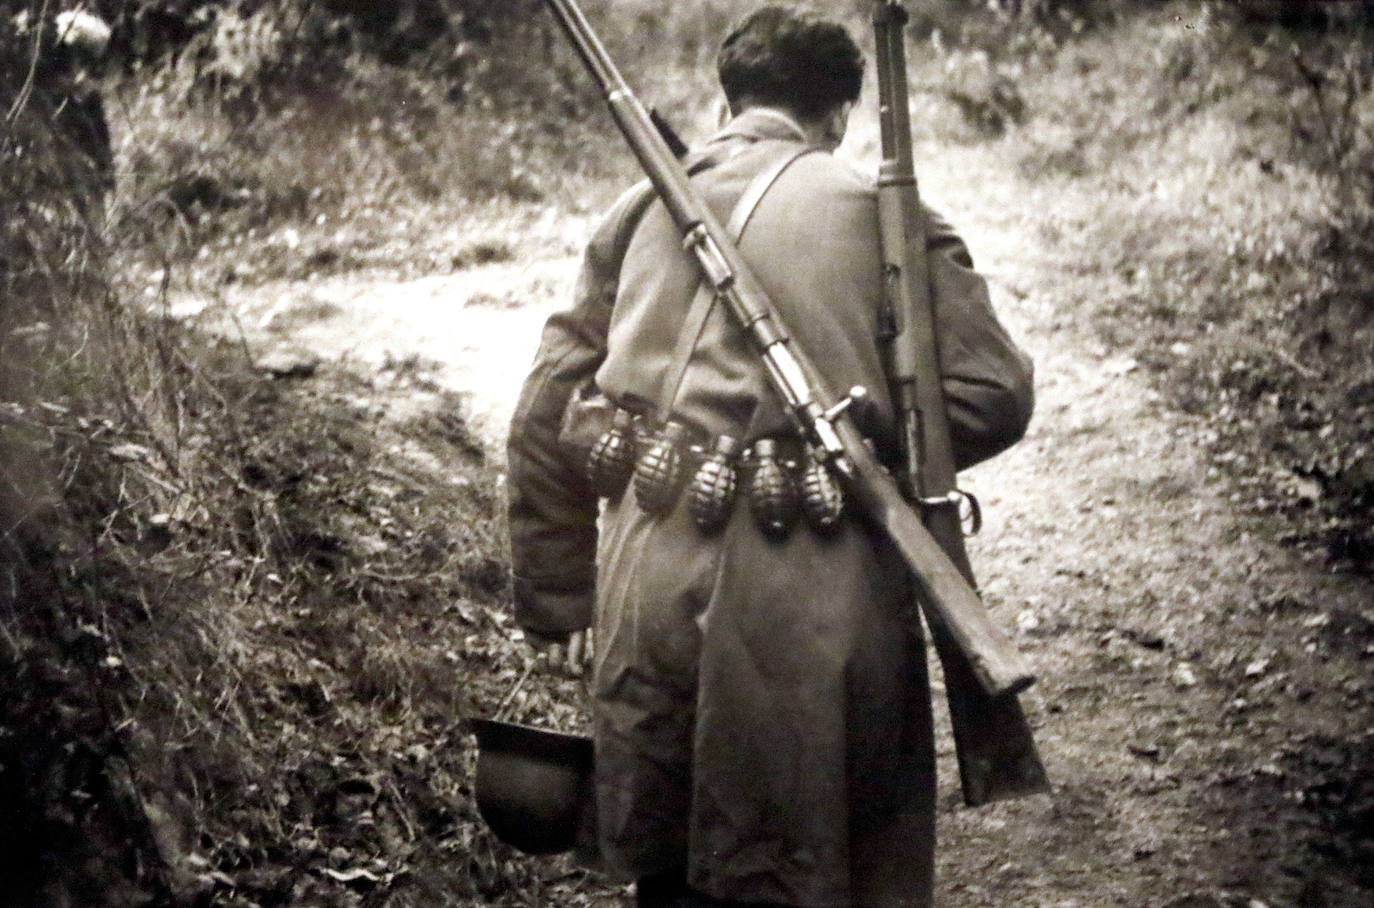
xmin=196 ymin=144 xmax=1374 ymax=908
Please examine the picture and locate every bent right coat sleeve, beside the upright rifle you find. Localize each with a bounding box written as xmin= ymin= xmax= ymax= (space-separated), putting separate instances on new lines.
xmin=926 ymin=209 xmax=1035 ymax=470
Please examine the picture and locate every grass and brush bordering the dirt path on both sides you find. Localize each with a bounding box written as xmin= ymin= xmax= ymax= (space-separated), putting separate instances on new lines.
xmin=0 ymin=0 xmax=1374 ymax=905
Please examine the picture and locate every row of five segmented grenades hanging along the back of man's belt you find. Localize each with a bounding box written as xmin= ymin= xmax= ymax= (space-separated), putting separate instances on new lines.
xmin=587 ymin=411 xmax=844 ymax=538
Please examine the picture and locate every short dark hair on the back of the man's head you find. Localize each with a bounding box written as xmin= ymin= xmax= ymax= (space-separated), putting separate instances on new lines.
xmin=716 ymin=5 xmax=863 ymax=120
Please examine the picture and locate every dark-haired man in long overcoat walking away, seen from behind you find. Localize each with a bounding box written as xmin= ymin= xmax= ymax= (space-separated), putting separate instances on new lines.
xmin=510 ymin=7 xmax=1032 ymax=908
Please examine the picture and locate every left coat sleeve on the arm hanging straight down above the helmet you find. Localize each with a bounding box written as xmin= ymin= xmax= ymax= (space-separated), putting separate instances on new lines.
xmin=507 ymin=187 xmax=651 ymax=640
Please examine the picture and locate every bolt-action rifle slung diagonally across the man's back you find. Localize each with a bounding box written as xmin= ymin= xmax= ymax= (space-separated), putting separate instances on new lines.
xmin=547 ymin=0 xmax=1033 ymax=696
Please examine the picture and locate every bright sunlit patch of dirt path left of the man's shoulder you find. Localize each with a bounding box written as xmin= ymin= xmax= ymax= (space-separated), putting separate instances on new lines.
xmin=172 ymin=217 xmax=589 ymax=456
